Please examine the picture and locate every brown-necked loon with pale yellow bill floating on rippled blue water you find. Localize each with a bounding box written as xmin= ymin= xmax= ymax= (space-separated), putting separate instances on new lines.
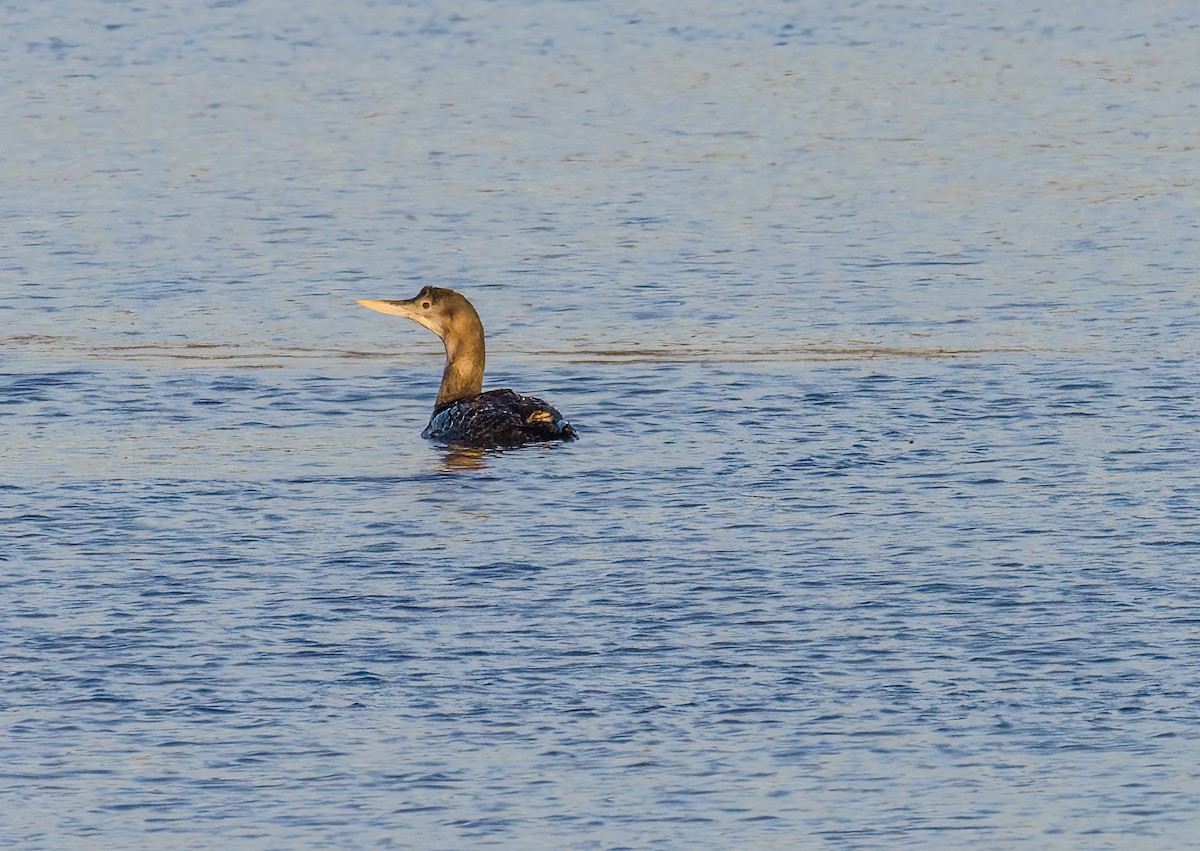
xmin=359 ymin=287 xmax=577 ymax=448
